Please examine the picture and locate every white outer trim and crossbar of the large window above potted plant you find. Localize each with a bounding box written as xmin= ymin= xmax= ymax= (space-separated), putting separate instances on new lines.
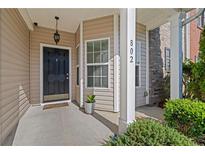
xmin=85 ymin=37 xmax=110 ymax=90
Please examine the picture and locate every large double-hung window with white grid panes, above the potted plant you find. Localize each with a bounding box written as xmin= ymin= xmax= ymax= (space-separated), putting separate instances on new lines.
xmin=86 ymin=39 xmax=109 ymax=88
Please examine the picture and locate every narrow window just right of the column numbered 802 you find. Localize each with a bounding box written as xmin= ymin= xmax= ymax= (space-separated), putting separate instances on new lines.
xmin=135 ymin=41 xmax=142 ymax=87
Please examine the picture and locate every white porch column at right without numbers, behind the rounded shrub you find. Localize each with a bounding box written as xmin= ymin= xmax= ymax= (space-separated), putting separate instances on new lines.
xmin=170 ymin=13 xmax=183 ymax=99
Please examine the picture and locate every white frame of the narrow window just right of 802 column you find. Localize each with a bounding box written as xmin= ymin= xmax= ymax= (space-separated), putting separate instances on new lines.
xmin=135 ymin=40 xmax=142 ymax=88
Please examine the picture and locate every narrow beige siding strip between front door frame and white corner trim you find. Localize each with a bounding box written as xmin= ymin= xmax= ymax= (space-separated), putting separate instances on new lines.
xmin=75 ymin=26 xmax=80 ymax=103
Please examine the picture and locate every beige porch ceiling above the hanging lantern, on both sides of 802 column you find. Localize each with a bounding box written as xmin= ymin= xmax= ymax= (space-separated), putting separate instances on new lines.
xmin=22 ymin=8 xmax=178 ymax=32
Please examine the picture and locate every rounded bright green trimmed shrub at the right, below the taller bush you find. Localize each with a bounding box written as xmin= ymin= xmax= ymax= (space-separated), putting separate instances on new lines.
xmin=164 ymin=99 xmax=205 ymax=139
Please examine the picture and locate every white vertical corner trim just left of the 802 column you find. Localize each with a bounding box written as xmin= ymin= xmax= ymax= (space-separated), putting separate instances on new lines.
xmin=114 ymin=13 xmax=120 ymax=112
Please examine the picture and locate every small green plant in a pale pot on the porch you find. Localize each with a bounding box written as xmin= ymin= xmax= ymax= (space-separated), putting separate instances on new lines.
xmin=85 ymin=95 xmax=95 ymax=114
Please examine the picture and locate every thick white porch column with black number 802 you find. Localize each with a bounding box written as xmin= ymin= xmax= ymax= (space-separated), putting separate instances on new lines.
xmin=119 ymin=8 xmax=136 ymax=133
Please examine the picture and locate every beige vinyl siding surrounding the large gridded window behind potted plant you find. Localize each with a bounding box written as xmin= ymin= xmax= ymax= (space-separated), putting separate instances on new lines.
xmin=83 ymin=16 xmax=114 ymax=111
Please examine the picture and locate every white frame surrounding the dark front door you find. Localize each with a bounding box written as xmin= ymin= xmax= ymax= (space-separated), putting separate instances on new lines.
xmin=40 ymin=43 xmax=72 ymax=105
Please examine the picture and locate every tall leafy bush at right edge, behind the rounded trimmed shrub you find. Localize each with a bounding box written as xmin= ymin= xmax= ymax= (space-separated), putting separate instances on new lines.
xmin=183 ymin=28 xmax=205 ymax=101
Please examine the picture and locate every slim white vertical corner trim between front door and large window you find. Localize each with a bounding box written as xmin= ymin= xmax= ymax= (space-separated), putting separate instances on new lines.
xmin=79 ymin=21 xmax=84 ymax=107
